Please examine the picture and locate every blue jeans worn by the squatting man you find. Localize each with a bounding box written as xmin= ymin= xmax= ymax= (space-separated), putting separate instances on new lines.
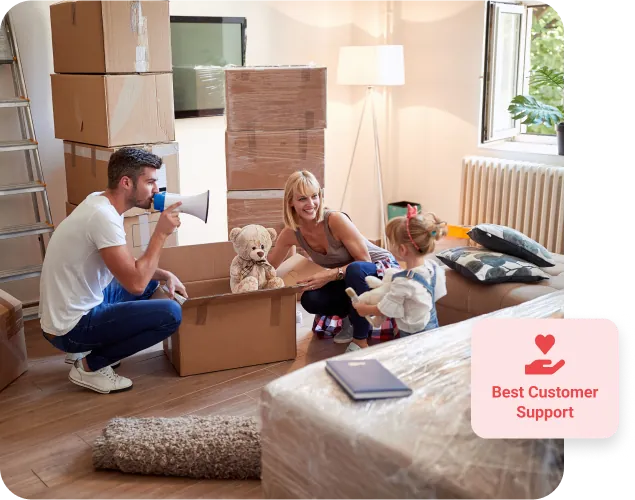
xmin=45 ymin=279 xmax=181 ymax=371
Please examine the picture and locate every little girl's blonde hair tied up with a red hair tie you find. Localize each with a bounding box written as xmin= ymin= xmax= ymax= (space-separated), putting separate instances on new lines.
xmin=386 ymin=208 xmax=448 ymax=255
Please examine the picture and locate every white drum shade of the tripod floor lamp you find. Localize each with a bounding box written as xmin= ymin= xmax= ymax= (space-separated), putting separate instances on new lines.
xmin=337 ymin=45 xmax=405 ymax=87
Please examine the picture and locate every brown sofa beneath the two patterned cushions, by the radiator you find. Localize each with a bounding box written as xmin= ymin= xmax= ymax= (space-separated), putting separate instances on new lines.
xmin=431 ymin=237 xmax=564 ymax=326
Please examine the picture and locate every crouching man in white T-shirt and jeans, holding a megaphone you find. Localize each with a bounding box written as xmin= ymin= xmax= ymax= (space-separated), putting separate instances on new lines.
xmin=40 ymin=148 xmax=187 ymax=394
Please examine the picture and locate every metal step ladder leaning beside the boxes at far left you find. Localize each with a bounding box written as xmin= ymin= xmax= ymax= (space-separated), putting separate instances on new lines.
xmin=0 ymin=13 xmax=54 ymax=320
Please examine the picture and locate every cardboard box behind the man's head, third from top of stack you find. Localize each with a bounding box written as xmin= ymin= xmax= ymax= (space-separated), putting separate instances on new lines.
xmin=64 ymin=141 xmax=179 ymax=205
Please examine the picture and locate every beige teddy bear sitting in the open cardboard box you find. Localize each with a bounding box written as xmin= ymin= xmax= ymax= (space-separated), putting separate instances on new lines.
xmin=229 ymin=224 xmax=285 ymax=293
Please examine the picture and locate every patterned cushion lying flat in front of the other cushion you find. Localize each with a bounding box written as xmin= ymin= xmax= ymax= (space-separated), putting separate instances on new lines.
xmin=436 ymin=246 xmax=549 ymax=284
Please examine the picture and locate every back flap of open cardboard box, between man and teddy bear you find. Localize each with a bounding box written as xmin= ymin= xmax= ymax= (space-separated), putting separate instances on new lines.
xmin=159 ymin=241 xmax=236 ymax=283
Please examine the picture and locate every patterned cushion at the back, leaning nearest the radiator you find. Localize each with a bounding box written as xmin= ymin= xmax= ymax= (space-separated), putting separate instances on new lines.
xmin=467 ymin=224 xmax=556 ymax=267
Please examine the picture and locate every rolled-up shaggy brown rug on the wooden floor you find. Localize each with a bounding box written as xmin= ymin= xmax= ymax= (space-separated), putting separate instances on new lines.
xmin=93 ymin=416 xmax=261 ymax=479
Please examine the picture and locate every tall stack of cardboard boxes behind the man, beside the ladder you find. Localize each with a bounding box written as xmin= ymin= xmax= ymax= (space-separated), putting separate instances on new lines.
xmin=50 ymin=0 xmax=179 ymax=256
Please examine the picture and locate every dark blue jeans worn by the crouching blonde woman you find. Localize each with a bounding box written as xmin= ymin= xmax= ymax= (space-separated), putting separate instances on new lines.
xmin=300 ymin=261 xmax=378 ymax=340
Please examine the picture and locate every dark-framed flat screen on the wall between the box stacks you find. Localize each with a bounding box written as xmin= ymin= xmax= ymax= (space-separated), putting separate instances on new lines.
xmin=170 ymin=16 xmax=247 ymax=118
